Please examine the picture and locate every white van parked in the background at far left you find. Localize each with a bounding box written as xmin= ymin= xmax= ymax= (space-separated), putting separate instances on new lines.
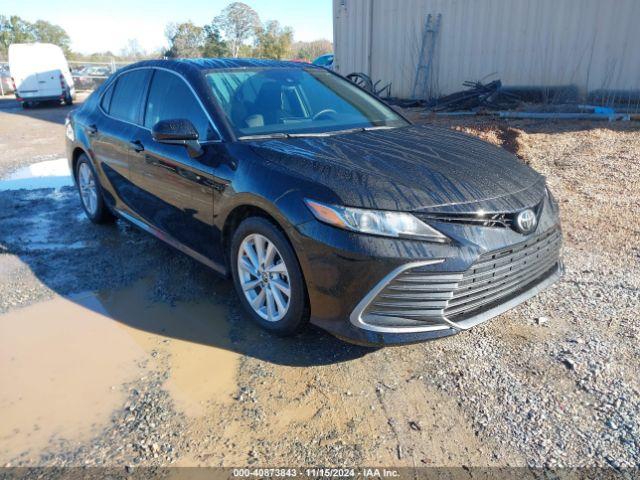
xmin=9 ymin=43 xmax=76 ymax=108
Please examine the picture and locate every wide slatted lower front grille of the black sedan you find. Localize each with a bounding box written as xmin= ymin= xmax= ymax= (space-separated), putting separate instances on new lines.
xmin=362 ymin=229 xmax=562 ymax=327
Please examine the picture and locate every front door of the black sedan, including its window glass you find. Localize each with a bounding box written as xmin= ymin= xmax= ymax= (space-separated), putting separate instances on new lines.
xmin=131 ymin=69 xmax=219 ymax=259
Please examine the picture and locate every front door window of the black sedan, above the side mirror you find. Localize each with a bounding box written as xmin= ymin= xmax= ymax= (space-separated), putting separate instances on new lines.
xmin=144 ymin=70 xmax=218 ymax=140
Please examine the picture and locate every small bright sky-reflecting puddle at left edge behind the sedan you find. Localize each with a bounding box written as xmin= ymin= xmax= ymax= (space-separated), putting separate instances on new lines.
xmin=0 ymin=158 xmax=73 ymax=191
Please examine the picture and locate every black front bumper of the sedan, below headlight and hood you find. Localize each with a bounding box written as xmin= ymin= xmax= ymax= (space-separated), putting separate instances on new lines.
xmin=294 ymin=202 xmax=563 ymax=345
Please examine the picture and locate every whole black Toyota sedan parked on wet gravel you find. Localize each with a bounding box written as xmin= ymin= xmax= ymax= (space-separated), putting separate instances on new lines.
xmin=66 ymin=59 xmax=563 ymax=344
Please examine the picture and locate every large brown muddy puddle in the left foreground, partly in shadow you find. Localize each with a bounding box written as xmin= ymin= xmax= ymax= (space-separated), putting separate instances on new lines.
xmin=0 ymin=281 xmax=239 ymax=464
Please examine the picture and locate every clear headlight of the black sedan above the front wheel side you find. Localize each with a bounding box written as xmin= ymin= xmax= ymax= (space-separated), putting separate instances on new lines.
xmin=305 ymin=199 xmax=447 ymax=243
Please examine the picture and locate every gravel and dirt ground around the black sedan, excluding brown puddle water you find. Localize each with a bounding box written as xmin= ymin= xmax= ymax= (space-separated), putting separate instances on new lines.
xmin=0 ymin=101 xmax=640 ymax=468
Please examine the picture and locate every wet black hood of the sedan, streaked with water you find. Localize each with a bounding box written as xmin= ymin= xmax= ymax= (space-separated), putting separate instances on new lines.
xmin=252 ymin=126 xmax=544 ymax=212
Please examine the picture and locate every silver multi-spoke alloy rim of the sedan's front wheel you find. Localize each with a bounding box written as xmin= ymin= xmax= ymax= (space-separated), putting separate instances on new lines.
xmin=238 ymin=233 xmax=291 ymax=322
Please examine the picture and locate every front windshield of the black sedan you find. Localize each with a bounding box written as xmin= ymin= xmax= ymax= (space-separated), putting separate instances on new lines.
xmin=206 ymin=67 xmax=407 ymax=139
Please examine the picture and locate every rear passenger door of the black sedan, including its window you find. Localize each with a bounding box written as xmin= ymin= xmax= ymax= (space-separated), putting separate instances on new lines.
xmin=86 ymin=69 xmax=151 ymax=208
